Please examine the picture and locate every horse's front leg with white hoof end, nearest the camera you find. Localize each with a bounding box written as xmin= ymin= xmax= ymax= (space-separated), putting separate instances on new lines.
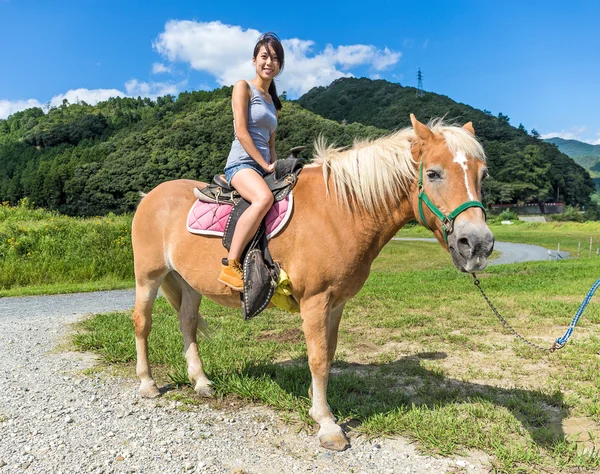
xmin=301 ymin=295 xmax=350 ymax=451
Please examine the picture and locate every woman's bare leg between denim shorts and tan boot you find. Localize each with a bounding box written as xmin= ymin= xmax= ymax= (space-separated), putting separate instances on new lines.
xmin=228 ymin=168 xmax=273 ymax=260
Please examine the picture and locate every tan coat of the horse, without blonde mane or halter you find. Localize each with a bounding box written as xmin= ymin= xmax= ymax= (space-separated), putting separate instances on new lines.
xmin=132 ymin=114 xmax=493 ymax=450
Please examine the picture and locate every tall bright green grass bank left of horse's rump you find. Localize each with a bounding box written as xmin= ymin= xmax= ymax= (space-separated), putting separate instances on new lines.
xmin=0 ymin=201 xmax=133 ymax=296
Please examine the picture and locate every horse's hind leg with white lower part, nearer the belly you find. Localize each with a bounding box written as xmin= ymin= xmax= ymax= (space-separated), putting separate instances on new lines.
xmin=163 ymin=273 xmax=214 ymax=398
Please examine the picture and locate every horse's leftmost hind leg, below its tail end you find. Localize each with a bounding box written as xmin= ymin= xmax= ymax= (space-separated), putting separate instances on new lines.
xmin=133 ymin=278 xmax=162 ymax=398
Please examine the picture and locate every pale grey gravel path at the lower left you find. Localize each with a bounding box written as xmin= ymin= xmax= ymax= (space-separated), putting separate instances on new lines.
xmin=0 ymin=290 xmax=488 ymax=474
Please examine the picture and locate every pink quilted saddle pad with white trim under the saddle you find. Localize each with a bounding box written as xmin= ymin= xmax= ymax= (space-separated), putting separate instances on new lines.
xmin=187 ymin=193 xmax=294 ymax=239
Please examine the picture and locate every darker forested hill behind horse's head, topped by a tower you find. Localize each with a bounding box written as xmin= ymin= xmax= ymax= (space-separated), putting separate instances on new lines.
xmin=298 ymin=78 xmax=595 ymax=213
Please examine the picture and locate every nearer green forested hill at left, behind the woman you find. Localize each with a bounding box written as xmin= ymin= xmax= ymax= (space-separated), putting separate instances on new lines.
xmin=0 ymin=87 xmax=385 ymax=215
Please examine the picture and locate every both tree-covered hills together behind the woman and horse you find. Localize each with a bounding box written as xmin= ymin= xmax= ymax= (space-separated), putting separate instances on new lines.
xmin=0 ymin=79 xmax=595 ymax=216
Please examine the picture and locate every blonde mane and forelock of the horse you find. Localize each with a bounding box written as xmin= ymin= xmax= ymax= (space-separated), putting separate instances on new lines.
xmin=314 ymin=119 xmax=485 ymax=214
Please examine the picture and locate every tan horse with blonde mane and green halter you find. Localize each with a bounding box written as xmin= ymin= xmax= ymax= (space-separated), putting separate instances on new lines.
xmin=132 ymin=114 xmax=494 ymax=451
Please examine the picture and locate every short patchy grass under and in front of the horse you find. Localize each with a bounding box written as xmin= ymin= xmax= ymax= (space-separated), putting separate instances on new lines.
xmin=74 ymin=237 xmax=600 ymax=473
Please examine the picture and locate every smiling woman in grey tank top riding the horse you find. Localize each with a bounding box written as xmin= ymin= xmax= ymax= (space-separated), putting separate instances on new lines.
xmin=219 ymin=33 xmax=284 ymax=291
